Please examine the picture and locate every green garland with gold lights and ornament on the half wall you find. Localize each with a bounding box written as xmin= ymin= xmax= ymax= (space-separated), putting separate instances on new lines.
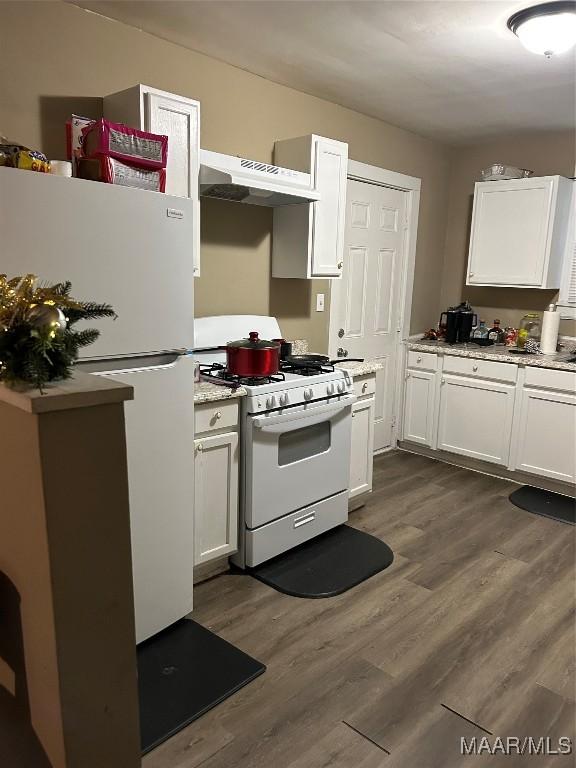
xmin=0 ymin=275 xmax=116 ymax=390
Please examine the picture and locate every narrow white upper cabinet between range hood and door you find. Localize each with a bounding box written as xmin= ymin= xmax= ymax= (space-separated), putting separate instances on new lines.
xmin=272 ymin=134 xmax=348 ymax=278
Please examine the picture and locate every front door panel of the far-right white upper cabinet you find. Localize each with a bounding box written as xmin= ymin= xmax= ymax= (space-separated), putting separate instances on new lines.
xmin=467 ymin=178 xmax=554 ymax=286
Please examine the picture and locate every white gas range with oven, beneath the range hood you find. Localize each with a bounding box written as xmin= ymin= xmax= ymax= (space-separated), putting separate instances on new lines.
xmin=195 ymin=315 xmax=356 ymax=568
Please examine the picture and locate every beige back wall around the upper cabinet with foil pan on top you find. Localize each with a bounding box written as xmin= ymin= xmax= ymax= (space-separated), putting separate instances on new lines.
xmin=441 ymin=131 xmax=576 ymax=336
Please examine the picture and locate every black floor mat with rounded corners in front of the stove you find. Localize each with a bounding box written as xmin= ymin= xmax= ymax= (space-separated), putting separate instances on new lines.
xmin=248 ymin=525 xmax=394 ymax=598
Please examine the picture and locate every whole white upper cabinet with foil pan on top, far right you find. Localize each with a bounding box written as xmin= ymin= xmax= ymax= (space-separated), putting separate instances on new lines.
xmin=466 ymin=176 xmax=573 ymax=289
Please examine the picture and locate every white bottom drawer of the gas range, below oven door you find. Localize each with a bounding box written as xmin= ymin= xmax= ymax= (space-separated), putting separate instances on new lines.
xmin=245 ymin=491 xmax=348 ymax=567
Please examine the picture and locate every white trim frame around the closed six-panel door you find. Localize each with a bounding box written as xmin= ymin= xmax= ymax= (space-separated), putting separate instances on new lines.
xmin=328 ymin=160 xmax=422 ymax=452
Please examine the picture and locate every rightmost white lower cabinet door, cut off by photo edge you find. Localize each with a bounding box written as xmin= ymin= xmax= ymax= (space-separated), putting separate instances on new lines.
xmin=515 ymin=387 xmax=576 ymax=483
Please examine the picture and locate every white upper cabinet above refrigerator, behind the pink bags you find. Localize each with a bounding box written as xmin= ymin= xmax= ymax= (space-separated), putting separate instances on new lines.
xmin=104 ymin=85 xmax=200 ymax=277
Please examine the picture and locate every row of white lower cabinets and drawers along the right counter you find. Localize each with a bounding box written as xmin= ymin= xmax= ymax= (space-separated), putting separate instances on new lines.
xmin=402 ymin=350 xmax=576 ymax=484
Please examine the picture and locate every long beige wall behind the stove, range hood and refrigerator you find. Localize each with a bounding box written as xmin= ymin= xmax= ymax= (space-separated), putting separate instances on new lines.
xmin=0 ymin=2 xmax=449 ymax=351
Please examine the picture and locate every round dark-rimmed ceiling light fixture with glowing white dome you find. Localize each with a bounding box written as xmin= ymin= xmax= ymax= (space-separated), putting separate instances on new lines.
xmin=508 ymin=0 xmax=576 ymax=59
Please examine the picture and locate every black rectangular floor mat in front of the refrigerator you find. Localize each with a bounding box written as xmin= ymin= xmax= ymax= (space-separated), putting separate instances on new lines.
xmin=138 ymin=619 xmax=266 ymax=753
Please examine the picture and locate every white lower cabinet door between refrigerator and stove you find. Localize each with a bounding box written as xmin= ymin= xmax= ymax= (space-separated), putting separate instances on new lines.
xmin=194 ymin=432 xmax=238 ymax=565
